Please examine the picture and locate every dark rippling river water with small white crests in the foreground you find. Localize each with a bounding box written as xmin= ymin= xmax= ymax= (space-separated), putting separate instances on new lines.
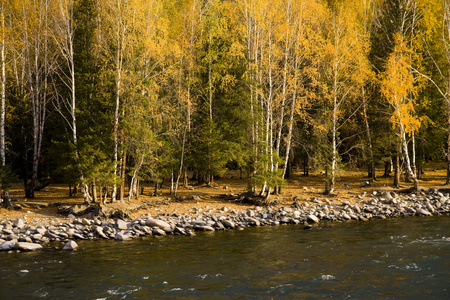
xmin=0 ymin=216 xmax=450 ymax=300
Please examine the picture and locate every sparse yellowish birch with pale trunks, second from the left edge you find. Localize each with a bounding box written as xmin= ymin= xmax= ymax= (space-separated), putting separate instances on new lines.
xmin=10 ymin=0 xmax=55 ymax=198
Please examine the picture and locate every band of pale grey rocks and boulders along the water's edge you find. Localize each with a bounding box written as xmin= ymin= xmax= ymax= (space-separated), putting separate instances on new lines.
xmin=0 ymin=189 xmax=450 ymax=251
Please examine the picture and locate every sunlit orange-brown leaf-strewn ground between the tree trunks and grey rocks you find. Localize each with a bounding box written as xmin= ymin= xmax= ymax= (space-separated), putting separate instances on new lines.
xmin=0 ymin=163 xmax=448 ymax=223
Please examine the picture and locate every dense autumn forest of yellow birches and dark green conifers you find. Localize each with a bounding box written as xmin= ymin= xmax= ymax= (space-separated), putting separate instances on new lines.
xmin=0 ymin=0 xmax=450 ymax=205
